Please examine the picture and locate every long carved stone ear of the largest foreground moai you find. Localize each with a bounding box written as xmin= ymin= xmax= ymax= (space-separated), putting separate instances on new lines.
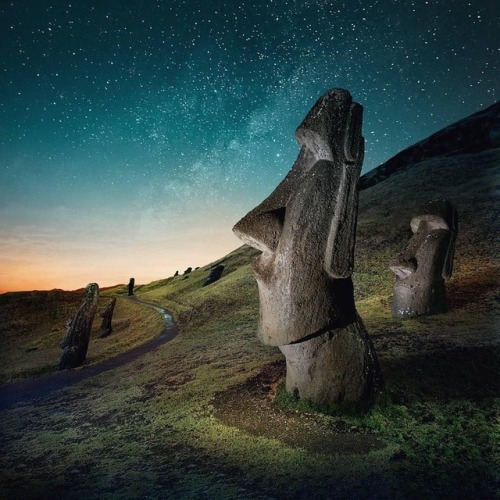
xmin=325 ymin=103 xmax=364 ymax=279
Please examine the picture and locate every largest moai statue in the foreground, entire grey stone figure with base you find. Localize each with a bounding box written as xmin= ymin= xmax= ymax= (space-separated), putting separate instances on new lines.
xmin=233 ymin=89 xmax=380 ymax=404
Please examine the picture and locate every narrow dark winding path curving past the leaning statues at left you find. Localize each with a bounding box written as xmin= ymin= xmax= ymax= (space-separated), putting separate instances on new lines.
xmin=0 ymin=296 xmax=178 ymax=411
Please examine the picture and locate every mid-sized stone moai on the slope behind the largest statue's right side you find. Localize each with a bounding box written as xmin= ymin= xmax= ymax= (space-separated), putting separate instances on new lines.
xmin=389 ymin=200 xmax=458 ymax=318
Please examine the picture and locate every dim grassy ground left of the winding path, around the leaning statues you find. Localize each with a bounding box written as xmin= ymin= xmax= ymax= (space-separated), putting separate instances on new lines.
xmin=0 ymin=289 xmax=163 ymax=384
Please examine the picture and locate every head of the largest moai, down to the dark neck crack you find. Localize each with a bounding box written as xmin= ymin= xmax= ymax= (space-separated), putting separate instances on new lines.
xmin=233 ymin=89 xmax=364 ymax=346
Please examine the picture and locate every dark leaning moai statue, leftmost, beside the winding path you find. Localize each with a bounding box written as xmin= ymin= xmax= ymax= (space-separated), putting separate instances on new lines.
xmin=58 ymin=283 xmax=99 ymax=370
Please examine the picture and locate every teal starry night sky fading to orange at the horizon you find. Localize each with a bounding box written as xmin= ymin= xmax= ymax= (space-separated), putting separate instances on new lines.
xmin=0 ymin=0 xmax=500 ymax=292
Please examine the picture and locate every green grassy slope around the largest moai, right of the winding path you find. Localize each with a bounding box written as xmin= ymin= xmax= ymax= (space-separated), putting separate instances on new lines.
xmin=0 ymin=108 xmax=500 ymax=499
